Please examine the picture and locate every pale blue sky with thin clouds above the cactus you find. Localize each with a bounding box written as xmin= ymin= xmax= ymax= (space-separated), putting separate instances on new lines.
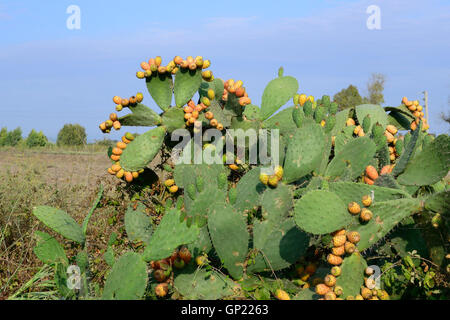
xmin=0 ymin=0 xmax=450 ymax=141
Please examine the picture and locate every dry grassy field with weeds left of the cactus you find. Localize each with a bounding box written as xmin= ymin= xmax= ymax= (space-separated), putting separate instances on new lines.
xmin=0 ymin=146 xmax=134 ymax=299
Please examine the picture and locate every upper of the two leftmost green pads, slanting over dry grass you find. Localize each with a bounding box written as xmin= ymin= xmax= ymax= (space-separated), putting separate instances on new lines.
xmin=33 ymin=206 xmax=85 ymax=244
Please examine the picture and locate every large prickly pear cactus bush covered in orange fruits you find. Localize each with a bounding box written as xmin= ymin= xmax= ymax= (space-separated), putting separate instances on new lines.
xmin=29 ymin=56 xmax=450 ymax=300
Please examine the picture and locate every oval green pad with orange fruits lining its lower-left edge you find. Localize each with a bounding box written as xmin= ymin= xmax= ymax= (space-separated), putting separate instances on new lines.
xmin=120 ymin=127 xmax=166 ymax=172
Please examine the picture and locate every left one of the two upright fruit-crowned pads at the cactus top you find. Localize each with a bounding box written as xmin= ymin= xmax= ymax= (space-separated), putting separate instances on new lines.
xmin=145 ymin=74 xmax=172 ymax=111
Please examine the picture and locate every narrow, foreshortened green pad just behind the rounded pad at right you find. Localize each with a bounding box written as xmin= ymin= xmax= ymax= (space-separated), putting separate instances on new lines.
xmin=329 ymin=182 xmax=410 ymax=204
